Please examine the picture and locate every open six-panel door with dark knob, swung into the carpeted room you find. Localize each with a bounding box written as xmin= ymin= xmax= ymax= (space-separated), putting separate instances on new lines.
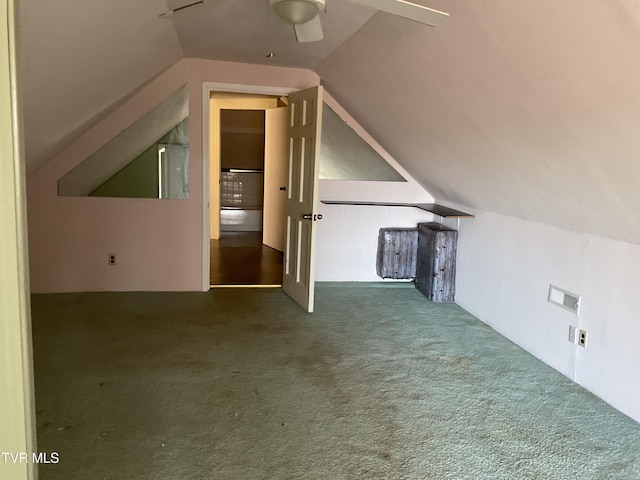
xmin=282 ymin=86 xmax=322 ymax=312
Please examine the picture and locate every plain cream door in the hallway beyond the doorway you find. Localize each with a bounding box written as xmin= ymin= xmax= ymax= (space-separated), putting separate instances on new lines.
xmin=262 ymin=107 xmax=289 ymax=252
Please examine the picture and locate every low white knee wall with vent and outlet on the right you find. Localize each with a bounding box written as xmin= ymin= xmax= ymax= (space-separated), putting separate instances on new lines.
xmin=445 ymin=212 xmax=640 ymax=421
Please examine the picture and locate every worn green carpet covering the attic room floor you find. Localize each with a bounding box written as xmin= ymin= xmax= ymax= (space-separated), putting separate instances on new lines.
xmin=32 ymin=284 xmax=640 ymax=480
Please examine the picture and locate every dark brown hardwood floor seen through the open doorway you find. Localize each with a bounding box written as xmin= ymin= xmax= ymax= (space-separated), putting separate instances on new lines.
xmin=210 ymin=232 xmax=282 ymax=285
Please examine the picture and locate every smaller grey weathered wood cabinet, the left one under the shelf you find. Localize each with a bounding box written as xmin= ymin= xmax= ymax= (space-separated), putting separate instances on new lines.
xmin=376 ymin=228 xmax=418 ymax=279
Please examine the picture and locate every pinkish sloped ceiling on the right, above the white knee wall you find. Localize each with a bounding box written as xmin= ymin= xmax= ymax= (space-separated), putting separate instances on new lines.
xmin=317 ymin=0 xmax=640 ymax=243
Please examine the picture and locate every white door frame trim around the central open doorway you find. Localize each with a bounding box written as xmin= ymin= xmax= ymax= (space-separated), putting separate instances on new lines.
xmin=202 ymin=82 xmax=300 ymax=292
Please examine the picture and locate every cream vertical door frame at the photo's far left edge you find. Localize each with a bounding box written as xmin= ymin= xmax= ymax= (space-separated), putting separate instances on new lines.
xmin=0 ymin=0 xmax=38 ymax=480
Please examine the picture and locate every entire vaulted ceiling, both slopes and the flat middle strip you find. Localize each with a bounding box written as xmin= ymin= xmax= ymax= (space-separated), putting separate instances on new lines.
xmin=19 ymin=0 xmax=640 ymax=243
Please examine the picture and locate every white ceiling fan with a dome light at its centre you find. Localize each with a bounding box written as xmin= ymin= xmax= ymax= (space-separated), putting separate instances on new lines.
xmin=160 ymin=0 xmax=449 ymax=43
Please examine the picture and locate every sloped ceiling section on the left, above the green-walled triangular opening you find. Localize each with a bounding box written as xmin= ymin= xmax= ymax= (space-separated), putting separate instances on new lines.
xmin=16 ymin=0 xmax=182 ymax=170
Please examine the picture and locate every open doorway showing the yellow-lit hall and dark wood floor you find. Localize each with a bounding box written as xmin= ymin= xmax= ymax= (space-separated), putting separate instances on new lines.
xmin=209 ymin=94 xmax=286 ymax=287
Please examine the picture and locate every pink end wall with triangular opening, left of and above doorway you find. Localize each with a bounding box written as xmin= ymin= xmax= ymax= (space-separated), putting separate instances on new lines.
xmin=27 ymin=58 xmax=319 ymax=293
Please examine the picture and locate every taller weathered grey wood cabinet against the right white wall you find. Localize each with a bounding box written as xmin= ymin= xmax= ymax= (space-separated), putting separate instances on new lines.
xmin=416 ymin=223 xmax=458 ymax=302
